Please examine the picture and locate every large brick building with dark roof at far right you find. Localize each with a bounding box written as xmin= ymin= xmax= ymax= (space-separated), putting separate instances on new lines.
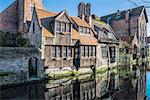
xmin=101 ymin=6 xmax=148 ymax=57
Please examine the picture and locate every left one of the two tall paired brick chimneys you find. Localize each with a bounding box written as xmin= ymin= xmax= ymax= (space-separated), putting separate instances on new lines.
xmin=78 ymin=2 xmax=85 ymax=20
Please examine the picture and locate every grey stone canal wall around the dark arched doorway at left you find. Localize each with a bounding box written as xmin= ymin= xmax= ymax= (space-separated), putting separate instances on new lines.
xmin=0 ymin=47 xmax=44 ymax=84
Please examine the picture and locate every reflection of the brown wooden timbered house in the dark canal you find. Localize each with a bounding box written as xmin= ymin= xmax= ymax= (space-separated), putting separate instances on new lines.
xmin=45 ymin=77 xmax=96 ymax=100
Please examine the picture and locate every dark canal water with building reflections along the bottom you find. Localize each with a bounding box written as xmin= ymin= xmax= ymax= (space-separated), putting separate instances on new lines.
xmin=0 ymin=63 xmax=150 ymax=100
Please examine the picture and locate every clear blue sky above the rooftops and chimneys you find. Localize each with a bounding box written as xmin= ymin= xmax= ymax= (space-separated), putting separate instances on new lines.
xmin=0 ymin=0 xmax=150 ymax=36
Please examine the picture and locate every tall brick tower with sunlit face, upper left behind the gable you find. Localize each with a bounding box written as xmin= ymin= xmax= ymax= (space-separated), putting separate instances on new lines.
xmin=17 ymin=0 xmax=44 ymax=33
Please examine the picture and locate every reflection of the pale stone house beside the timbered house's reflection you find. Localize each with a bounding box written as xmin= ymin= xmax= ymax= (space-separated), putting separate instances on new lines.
xmin=96 ymin=70 xmax=119 ymax=98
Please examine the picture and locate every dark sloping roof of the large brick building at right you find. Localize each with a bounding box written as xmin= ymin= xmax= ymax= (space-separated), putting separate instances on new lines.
xmin=101 ymin=6 xmax=145 ymax=22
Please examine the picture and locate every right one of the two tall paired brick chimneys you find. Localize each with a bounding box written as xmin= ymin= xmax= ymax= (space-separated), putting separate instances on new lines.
xmin=85 ymin=3 xmax=92 ymax=25
